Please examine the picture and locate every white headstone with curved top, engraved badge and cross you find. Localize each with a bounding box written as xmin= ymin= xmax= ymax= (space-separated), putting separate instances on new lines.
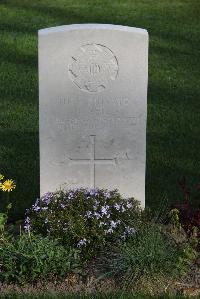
xmin=39 ymin=24 xmax=148 ymax=206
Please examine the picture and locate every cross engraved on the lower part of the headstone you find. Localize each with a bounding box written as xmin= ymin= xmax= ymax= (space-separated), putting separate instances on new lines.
xmin=70 ymin=135 xmax=116 ymax=188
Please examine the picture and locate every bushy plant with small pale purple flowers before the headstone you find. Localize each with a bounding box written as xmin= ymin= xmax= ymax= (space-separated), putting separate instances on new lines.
xmin=25 ymin=188 xmax=140 ymax=259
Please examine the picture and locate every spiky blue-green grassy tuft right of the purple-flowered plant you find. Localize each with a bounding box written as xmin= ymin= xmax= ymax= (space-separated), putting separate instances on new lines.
xmin=108 ymin=223 xmax=191 ymax=284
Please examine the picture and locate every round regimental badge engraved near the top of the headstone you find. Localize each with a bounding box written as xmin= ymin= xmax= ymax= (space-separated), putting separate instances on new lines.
xmin=68 ymin=44 xmax=119 ymax=92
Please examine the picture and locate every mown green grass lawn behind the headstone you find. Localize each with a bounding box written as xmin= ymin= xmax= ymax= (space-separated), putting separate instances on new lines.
xmin=0 ymin=0 xmax=200 ymax=218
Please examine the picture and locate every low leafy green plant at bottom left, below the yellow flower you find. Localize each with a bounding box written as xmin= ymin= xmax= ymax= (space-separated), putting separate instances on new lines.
xmin=0 ymin=234 xmax=80 ymax=283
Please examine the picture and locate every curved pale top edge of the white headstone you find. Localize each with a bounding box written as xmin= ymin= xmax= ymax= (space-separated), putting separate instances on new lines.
xmin=38 ymin=23 xmax=148 ymax=35
